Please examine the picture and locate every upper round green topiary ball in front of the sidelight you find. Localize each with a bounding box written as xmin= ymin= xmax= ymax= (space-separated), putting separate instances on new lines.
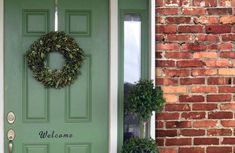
xmin=128 ymin=80 xmax=165 ymax=121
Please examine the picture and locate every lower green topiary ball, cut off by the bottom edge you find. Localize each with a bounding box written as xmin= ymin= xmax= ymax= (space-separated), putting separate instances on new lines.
xmin=122 ymin=137 xmax=159 ymax=153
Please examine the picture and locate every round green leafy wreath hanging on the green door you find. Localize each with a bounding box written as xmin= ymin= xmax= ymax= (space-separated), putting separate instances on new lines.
xmin=26 ymin=32 xmax=85 ymax=88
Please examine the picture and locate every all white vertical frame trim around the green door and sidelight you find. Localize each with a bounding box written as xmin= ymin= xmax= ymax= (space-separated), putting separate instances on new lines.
xmin=0 ymin=0 xmax=155 ymax=153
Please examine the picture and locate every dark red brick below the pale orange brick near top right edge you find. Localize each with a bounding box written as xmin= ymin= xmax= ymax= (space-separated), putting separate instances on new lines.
xmin=206 ymin=25 xmax=232 ymax=34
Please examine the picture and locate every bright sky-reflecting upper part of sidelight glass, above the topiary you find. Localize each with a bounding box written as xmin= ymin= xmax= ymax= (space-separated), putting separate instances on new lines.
xmin=124 ymin=14 xmax=141 ymax=83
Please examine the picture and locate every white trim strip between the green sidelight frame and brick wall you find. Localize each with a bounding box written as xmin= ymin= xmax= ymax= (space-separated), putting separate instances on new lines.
xmin=149 ymin=0 xmax=155 ymax=139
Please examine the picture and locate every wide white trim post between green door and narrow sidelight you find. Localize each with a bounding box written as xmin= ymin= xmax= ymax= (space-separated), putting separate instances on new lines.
xmin=109 ymin=0 xmax=118 ymax=153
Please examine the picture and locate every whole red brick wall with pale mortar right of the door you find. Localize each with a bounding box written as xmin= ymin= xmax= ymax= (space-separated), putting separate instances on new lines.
xmin=156 ymin=0 xmax=235 ymax=153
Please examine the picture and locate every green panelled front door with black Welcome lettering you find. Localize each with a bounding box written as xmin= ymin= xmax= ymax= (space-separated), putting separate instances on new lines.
xmin=4 ymin=0 xmax=109 ymax=153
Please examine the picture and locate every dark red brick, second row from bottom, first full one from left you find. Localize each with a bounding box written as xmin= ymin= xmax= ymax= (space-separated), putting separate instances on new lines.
xmin=166 ymin=138 xmax=192 ymax=146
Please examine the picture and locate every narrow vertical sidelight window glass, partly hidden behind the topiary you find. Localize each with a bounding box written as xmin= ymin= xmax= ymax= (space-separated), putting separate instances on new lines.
xmin=124 ymin=14 xmax=141 ymax=140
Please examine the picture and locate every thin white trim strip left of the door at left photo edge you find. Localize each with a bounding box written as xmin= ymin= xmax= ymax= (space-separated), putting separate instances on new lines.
xmin=0 ymin=0 xmax=4 ymax=153
